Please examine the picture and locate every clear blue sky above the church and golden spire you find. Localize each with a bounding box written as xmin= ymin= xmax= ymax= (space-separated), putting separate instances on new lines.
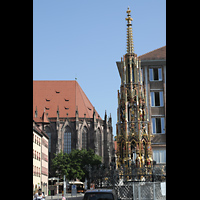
xmin=33 ymin=0 xmax=166 ymax=135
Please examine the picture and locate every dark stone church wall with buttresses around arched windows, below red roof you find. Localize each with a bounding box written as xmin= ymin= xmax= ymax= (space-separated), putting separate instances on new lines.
xmin=37 ymin=113 xmax=113 ymax=177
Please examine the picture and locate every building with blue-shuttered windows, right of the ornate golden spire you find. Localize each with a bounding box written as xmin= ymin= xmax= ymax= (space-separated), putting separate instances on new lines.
xmin=139 ymin=46 xmax=167 ymax=164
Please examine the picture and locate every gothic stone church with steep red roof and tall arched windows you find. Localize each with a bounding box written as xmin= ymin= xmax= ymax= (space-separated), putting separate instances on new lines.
xmin=33 ymin=80 xmax=114 ymax=177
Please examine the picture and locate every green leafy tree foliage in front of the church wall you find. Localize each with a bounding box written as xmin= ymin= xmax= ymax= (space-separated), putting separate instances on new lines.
xmin=52 ymin=149 xmax=101 ymax=180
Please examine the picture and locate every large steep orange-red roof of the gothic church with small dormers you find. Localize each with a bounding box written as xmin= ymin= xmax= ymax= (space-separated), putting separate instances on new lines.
xmin=33 ymin=81 xmax=101 ymax=121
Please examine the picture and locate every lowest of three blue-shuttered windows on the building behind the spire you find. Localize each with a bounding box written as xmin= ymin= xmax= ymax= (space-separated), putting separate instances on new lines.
xmin=152 ymin=117 xmax=165 ymax=134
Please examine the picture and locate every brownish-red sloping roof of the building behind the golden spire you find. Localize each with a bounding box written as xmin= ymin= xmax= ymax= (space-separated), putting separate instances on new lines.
xmin=138 ymin=46 xmax=166 ymax=60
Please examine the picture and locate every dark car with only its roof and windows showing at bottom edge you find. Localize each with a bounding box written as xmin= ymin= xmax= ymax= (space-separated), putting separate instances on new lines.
xmin=83 ymin=189 xmax=120 ymax=200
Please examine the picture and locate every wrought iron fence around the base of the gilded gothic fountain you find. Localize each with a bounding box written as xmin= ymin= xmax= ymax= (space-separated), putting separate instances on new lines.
xmin=89 ymin=164 xmax=166 ymax=200
